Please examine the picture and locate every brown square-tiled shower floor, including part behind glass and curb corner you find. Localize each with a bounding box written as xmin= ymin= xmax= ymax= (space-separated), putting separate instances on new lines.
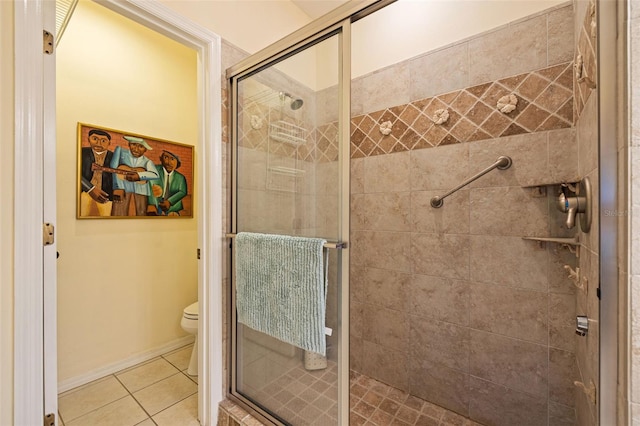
xmin=228 ymin=361 xmax=482 ymax=426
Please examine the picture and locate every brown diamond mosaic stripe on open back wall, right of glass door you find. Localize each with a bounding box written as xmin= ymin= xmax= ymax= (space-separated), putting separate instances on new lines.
xmin=351 ymin=62 xmax=574 ymax=158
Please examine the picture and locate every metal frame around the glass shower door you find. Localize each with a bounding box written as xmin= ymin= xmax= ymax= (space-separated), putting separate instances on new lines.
xmin=226 ymin=0 xmax=396 ymax=426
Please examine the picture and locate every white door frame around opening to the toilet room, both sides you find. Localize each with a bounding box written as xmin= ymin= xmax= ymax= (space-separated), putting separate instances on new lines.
xmin=13 ymin=0 xmax=224 ymax=425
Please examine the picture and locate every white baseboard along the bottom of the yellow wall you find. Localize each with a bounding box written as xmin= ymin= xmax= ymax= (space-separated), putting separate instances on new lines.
xmin=58 ymin=335 xmax=195 ymax=393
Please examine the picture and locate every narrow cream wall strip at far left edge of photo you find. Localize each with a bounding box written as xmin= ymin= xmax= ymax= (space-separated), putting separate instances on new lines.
xmin=0 ymin=1 xmax=13 ymax=425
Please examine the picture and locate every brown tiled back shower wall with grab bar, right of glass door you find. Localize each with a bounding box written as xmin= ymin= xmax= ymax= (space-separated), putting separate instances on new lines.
xmin=351 ymin=5 xmax=597 ymax=425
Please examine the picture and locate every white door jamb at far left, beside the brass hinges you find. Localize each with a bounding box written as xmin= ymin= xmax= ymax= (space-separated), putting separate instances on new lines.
xmin=13 ymin=0 xmax=44 ymax=425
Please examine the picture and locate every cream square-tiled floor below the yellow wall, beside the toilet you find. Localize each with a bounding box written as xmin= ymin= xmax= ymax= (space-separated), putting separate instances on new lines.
xmin=58 ymin=345 xmax=200 ymax=426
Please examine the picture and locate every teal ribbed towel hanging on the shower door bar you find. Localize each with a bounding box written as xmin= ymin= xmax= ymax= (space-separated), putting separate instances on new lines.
xmin=235 ymin=232 xmax=327 ymax=355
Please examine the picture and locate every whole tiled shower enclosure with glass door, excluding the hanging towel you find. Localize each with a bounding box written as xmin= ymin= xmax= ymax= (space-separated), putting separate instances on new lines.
xmin=228 ymin=0 xmax=603 ymax=425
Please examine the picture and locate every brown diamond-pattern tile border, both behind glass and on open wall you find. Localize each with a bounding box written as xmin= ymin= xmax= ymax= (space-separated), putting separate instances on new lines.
xmin=234 ymin=62 xmax=583 ymax=163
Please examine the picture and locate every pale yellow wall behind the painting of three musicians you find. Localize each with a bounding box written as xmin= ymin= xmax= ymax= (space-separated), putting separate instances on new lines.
xmin=56 ymin=2 xmax=198 ymax=383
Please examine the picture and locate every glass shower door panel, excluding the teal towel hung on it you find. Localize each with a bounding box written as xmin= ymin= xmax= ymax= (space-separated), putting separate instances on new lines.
xmin=231 ymin=28 xmax=348 ymax=425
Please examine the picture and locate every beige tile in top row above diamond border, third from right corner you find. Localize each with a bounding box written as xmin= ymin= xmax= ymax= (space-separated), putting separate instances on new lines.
xmin=409 ymin=42 xmax=469 ymax=101
